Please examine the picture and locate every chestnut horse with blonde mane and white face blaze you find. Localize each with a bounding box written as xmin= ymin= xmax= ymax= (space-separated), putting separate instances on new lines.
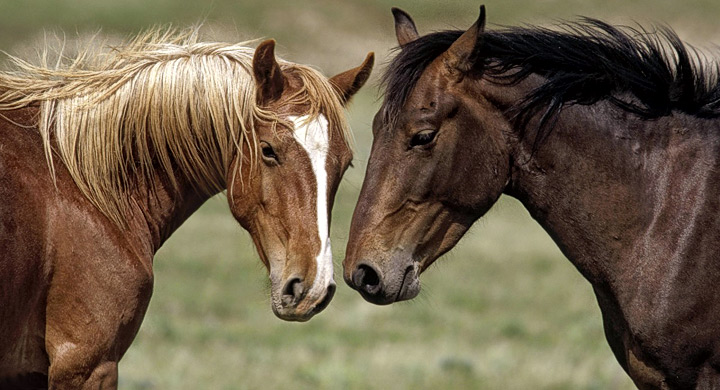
xmin=0 ymin=29 xmax=373 ymax=389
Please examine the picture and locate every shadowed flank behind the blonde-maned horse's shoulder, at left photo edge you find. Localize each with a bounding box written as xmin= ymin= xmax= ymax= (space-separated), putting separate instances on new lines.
xmin=0 ymin=112 xmax=56 ymax=382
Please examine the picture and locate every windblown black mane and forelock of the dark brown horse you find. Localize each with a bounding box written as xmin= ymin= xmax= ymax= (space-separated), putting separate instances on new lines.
xmin=382 ymin=19 xmax=720 ymax=136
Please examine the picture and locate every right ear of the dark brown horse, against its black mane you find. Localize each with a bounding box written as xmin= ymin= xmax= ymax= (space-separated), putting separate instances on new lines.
xmin=443 ymin=5 xmax=485 ymax=81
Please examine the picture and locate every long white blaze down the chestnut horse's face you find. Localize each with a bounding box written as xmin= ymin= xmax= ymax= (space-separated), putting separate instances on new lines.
xmin=288 ymin=115 xmax=334 ymax=301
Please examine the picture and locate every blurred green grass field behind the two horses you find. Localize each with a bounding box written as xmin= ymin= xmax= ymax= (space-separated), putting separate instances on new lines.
xmin=0 ymin=0 xmax=720 ymax=390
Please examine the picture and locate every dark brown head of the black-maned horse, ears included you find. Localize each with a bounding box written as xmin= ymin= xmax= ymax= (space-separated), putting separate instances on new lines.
xmin=343 ymin=7 xmax=510 ymax=304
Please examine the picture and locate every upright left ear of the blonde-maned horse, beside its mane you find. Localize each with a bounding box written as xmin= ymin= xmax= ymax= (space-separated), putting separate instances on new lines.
xmin=253 ymin=39 xmax=285 ymax=106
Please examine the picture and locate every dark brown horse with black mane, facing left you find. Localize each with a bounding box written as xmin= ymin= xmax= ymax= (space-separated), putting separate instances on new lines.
xmin=343 ymin=8 xmax=720 ymax=389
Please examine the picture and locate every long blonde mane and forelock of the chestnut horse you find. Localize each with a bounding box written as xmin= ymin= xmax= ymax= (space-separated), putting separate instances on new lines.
xmin=0 ymin=29 xmax=351 ymax=226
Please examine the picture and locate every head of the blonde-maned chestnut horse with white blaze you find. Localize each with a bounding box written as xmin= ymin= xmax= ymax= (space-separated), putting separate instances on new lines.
xmin=232 ymin=40 xmax=373 ymax=321
